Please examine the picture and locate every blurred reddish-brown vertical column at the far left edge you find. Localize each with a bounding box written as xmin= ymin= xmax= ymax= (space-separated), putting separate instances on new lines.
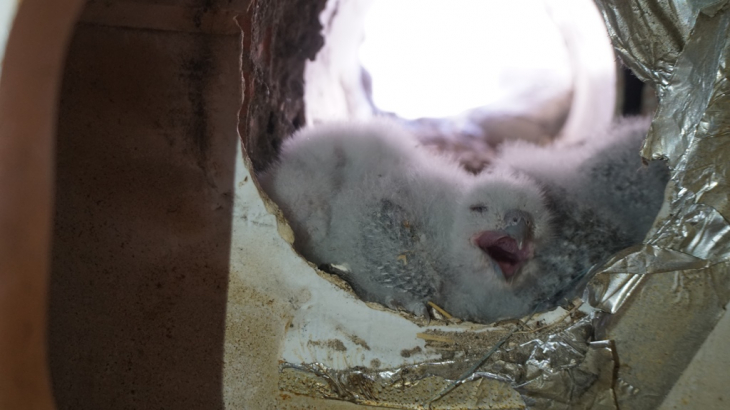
xmin=0 ymin=0 xmax=83 ymax=410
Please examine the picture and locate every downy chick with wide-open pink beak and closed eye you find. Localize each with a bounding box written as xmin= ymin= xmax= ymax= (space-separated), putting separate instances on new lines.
xmin=436 ymin=172 xmax=551 ymax=323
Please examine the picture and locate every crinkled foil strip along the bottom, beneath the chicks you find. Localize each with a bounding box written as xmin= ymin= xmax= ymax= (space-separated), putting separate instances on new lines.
xmin=279 ymin=310 xmax=616 ymax=409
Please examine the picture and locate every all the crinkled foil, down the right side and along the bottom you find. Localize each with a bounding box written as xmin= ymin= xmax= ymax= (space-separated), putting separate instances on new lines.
xmin=280 ymin=0 xmax=730 ymax=409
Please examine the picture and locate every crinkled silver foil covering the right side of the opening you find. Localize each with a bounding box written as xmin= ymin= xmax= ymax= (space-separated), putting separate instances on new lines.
xmin=589 ymin=0 xmax=730 ymax=409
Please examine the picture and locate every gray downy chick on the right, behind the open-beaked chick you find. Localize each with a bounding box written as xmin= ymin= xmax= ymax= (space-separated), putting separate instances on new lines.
xmin=494 ymin=118 xmax=669 ymax=310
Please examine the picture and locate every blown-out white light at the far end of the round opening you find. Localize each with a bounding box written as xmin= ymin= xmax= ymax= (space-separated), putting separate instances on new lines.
xmin=360 ymin=0 xmax=572 ymax=118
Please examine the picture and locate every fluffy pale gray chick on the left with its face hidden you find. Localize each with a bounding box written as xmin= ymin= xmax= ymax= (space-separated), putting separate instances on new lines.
xmin=260 ymin=122 xmax=463 ymax=315
